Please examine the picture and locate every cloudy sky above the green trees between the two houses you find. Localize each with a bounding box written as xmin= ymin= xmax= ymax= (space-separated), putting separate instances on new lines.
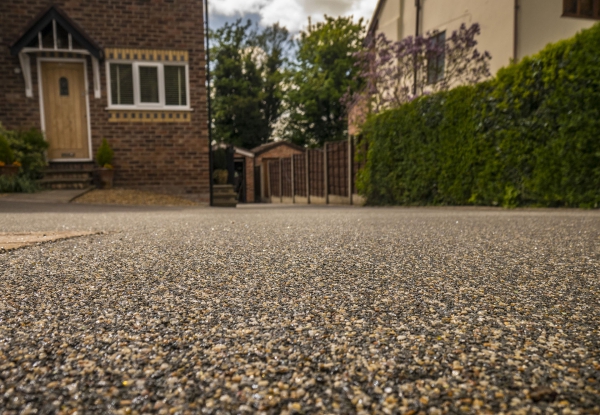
xmin=208 ymin=0 xmax=377 ymax=33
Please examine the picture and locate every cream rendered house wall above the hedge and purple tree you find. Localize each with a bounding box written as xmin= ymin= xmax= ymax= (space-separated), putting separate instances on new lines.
xmin=374 ymin=0 xmax=596 ymax=80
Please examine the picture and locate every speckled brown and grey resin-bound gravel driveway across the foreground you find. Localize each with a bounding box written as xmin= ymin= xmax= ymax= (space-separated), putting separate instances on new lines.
xmin=0 ymin=206 xmax=600 ymax=414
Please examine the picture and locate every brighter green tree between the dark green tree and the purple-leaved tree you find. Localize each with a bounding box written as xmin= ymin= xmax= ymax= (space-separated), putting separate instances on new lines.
xmin=285 ymin=16 xmax=365 ymax=146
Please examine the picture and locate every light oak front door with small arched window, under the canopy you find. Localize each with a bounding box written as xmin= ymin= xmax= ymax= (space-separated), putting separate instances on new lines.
xmin=41 ymin=62 xmax=90 ymax=160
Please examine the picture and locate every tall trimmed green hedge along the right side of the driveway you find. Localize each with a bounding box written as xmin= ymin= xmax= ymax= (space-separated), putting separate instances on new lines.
xmin=358 ymin=25 xmax=600 ymax=208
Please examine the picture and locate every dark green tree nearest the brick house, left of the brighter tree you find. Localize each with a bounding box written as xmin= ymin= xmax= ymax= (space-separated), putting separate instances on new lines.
xmin=211 ymin=19 xmax=290 ymax=148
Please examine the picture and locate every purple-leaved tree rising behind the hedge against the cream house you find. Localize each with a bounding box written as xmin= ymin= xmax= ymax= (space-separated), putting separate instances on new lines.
xmin=343 ymin=23 xmax=491 ymax=121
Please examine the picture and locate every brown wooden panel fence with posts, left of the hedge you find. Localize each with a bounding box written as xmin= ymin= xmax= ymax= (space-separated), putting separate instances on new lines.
xmin=268 ymin=140 xmax=364 ymax=204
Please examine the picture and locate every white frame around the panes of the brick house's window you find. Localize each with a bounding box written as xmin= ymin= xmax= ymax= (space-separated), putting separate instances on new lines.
xmin=106 ymin=59 xmax=192 ymax=111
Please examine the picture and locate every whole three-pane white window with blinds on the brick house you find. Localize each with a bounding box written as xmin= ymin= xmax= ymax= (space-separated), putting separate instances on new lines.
xmin=108 ymin=62 xmax=189 ymax=109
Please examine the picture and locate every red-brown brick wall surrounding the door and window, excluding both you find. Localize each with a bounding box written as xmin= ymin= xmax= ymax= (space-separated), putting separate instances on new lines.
xmin=0 ymin=0 xmax=209 ymax=202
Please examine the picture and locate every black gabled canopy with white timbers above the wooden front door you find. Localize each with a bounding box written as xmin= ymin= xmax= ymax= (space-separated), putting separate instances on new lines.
xmin=10 ymin=6 xmax=103 ymax=60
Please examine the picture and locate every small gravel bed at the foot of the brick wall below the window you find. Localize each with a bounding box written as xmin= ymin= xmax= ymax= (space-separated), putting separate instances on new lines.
xmin=73 ymin=189 xmax=196 ymax=206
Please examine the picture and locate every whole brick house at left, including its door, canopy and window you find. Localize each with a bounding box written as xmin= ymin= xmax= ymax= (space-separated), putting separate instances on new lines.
xmin=0 ymin=0 xmax=210 ymax=203
